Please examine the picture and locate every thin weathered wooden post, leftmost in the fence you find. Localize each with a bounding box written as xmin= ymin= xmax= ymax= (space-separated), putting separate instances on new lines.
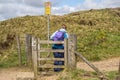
xmin=16 ymin=35 xmax=22 ymax=66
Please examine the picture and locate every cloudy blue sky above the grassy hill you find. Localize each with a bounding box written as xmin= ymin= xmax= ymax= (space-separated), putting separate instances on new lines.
xmin=0 ymin=0 xmax=120 ymax=21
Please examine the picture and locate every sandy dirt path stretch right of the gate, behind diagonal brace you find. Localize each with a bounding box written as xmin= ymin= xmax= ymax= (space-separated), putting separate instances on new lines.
xmin=77 ymin=57 xmax=120 ymax=71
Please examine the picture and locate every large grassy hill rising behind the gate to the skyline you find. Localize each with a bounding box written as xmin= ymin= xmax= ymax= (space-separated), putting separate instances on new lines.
xmin=0 ymin=8 xmax=120 ymax=67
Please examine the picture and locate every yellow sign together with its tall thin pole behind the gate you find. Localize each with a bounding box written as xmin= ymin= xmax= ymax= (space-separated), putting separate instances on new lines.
xmin=45 ymin=2 xmax=51 ymax=41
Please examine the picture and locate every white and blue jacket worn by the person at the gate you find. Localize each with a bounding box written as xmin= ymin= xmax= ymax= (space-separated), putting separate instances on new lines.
xmin=50 ymin=28 xmax=69 ymax=49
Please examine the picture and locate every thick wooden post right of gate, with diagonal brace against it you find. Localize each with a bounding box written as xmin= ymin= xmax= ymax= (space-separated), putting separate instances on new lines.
xmin=68 ymin=34 xmax=77 ymax=69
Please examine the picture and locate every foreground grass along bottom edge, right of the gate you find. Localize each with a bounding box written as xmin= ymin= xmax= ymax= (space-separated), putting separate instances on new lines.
xmin=57 ymin=69 xmax=118 ymax=80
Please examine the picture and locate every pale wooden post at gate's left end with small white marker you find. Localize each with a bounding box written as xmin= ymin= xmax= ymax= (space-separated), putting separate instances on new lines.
xmin=32 ymin=37 xmax=38 ymax=78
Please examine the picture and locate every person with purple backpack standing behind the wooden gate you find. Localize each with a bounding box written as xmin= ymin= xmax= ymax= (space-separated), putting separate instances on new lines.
xmin=50 ymin=24 xmax=68 ymax=72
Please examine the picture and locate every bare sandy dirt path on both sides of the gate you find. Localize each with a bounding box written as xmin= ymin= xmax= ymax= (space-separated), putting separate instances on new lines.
xmin=0 ymin=57 xmax=120 ymax=80
